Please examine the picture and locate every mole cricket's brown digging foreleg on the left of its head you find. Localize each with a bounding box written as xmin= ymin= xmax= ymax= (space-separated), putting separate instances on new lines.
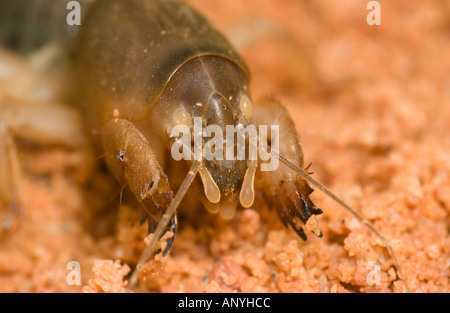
xmin=102 ymin=118 xmax=176 ymax=247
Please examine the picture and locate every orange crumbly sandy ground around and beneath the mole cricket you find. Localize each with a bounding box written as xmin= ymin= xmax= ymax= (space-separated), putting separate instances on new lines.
xmin=0 ymin=0 xmax=450 ymax=292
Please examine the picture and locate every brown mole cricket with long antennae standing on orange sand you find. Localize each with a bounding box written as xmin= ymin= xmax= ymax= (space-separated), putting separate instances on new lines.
xmin=0 ymin=0 xmax=408 ymax=290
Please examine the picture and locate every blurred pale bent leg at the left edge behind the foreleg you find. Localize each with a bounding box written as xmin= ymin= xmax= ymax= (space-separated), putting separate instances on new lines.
xmin=0 ymin=97 xmax=89 ymax=230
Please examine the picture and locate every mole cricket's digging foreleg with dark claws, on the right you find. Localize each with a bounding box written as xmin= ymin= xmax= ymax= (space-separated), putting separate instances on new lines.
xmin=253 ymin=102 xmax=322 ymax=240
